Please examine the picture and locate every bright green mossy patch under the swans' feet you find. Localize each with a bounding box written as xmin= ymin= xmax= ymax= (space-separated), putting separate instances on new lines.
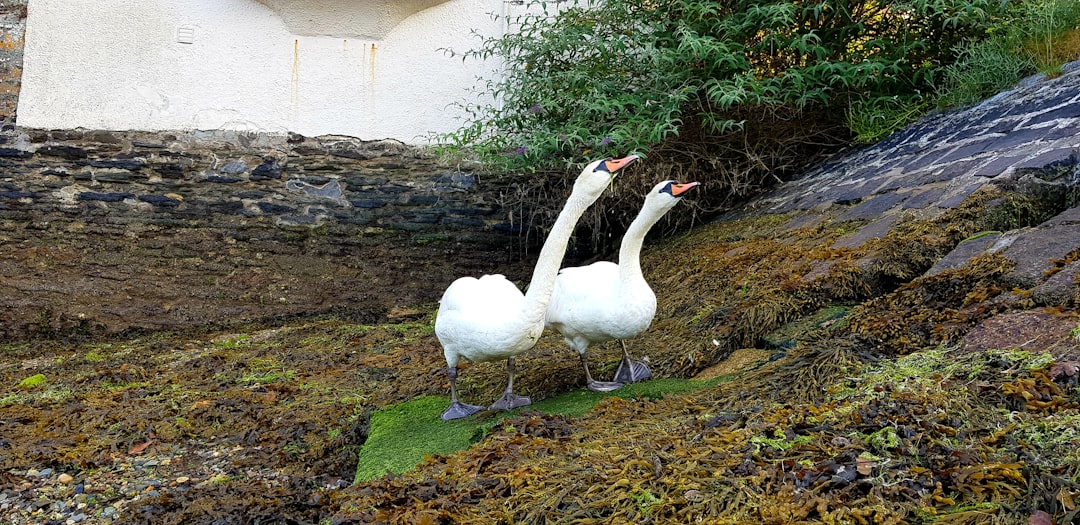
xmin=355 ymin=377 xmax=725 ymax=482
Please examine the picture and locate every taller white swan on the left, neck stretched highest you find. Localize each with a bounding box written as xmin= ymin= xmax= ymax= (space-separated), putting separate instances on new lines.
xmin=435 ymin=156 xmax=637 ymax=419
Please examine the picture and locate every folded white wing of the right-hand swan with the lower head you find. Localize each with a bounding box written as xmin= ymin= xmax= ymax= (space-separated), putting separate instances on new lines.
xmin=546 ymin=260 xmax=619 ymax=325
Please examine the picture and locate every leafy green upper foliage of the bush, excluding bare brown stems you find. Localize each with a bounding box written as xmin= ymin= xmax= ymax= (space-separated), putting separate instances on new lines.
xmin=441 ymin=0 xmax=1004 ymax=170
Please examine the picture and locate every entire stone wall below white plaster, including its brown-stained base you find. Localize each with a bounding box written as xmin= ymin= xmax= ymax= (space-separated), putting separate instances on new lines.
xmin=0 ymin=130 xmax=529 ymax=341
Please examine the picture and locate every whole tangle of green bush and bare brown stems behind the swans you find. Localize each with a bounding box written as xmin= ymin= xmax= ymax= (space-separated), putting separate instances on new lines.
xmin=437 ymin=0 xmax=1080 ymax=251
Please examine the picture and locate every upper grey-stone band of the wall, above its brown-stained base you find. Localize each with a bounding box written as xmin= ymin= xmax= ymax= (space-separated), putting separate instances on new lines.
xmin=0 ymin=130 xmax=518 ymax=242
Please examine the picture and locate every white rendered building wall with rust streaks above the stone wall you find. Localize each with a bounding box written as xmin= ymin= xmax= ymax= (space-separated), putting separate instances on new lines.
xmin=16 ymin=0 xmax=507 ymax=144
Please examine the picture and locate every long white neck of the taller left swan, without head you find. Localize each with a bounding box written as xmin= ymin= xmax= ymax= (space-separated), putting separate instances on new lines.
xmin=524 ymin=189 xmax=598 ymax=323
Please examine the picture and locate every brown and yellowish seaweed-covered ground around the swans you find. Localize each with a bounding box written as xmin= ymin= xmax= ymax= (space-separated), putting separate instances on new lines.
xmin=0 ymin=178 xmax=1080 ymax=524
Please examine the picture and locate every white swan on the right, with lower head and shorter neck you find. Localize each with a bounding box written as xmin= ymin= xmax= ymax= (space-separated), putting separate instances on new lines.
xmin=546 ymin=180 xmax=698 ymax=392
